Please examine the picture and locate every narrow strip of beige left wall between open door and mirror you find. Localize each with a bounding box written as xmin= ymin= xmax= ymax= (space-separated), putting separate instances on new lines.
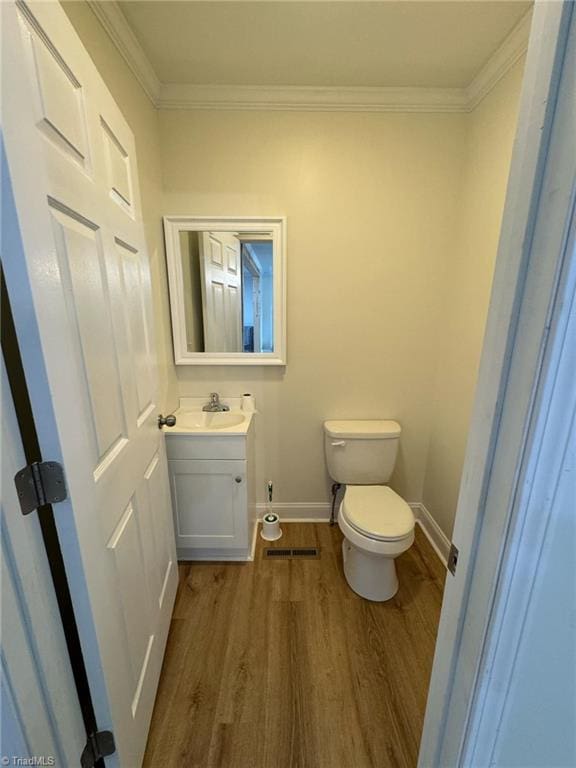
xmin=62 ymin=0 xmax=177 ymax=412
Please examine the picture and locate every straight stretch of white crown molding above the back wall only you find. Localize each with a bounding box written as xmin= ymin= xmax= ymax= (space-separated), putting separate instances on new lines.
xmin=158 ymin=83 xmax=466 ymax=112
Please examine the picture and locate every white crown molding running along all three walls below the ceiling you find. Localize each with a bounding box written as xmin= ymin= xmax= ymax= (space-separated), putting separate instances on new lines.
xmin=86 ymin=0 xmax=532 ymax=113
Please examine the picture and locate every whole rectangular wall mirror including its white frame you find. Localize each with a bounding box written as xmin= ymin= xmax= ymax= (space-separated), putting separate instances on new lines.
xmin=164 ymin=216 xmax=286 ymax=365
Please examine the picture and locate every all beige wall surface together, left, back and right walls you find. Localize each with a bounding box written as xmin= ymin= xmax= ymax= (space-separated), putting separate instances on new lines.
xmin=63 ymin=2 xmax=522 ymax=520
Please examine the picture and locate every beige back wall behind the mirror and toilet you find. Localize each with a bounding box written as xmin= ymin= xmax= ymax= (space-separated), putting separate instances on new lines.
xmin=160 ymin=111 xmax=465 ymax=503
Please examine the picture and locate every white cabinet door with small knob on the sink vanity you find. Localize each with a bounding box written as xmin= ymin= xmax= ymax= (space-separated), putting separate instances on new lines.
xmin=168 ymin=459 xmax=248 ymax=549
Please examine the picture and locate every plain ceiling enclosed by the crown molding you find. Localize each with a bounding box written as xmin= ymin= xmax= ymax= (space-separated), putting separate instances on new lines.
xmin=120 ymin=0 xmax=531 ymax=88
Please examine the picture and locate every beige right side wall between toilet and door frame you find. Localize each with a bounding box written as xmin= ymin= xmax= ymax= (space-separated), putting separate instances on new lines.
xmin=422 ymin=61 xmax=524 ymax=536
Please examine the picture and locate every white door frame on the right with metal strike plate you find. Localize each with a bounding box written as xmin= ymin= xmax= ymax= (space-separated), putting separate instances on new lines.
xmin=418 ymin=0 xmax=576 ymax=768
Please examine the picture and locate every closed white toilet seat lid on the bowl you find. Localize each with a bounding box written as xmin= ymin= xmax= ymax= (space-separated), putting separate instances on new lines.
xmin=340 ymin=485 xmax=414 ymax=542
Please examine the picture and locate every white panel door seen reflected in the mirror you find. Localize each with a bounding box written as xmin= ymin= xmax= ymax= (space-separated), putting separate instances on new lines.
xmin=198 ymin=232 xmax=242 ymax=352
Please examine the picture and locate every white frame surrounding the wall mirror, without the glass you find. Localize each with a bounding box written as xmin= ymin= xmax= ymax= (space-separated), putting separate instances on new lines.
xmin=164 ymin=216 xmax=286 ymax=365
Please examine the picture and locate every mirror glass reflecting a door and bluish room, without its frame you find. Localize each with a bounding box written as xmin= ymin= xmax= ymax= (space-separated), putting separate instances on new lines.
xmin=179 ymin=231 xmax=274 ymax=352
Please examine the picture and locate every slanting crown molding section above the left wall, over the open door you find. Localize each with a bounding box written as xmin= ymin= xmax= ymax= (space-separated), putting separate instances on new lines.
xmin=86 ymin=0 xmax=161 ymax=107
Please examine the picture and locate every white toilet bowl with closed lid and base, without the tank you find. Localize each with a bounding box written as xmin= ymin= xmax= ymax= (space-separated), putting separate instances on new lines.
xmin=338 ymin=485 xmax=414 ymax=601
